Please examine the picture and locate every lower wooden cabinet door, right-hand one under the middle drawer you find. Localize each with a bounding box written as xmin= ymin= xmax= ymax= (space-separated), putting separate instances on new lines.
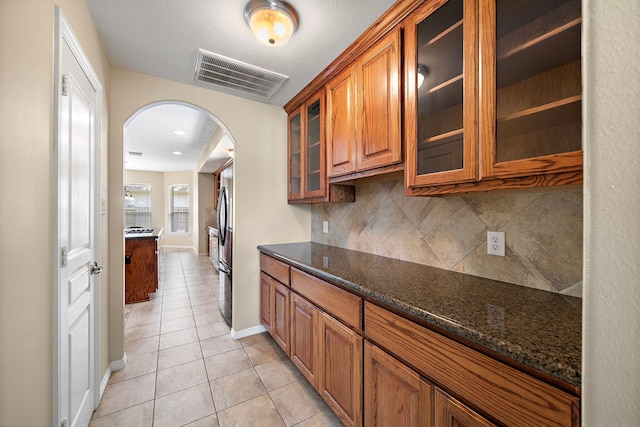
xmin=319 ymin=313 xmax=362 ymax=427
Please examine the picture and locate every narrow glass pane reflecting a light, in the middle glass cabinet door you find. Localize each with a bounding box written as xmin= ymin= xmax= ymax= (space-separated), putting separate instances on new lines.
xmin=417 ymin=0 xmax=464 ymax=175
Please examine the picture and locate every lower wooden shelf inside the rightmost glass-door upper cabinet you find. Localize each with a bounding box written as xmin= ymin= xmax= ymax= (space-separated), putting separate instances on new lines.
xmin=497 ymin=95 xmax=582 ymax=139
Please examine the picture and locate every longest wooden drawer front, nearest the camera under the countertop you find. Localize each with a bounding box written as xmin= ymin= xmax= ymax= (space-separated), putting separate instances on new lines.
xmin=364 ymin=303 xmax=580 ymax=426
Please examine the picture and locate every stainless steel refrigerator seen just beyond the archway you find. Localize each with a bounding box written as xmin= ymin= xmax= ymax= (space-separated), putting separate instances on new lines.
xmin=218 ymin=166 xmax=233 ymax=326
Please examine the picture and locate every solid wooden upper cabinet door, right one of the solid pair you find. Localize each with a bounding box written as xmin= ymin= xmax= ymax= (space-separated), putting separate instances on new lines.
xmin=357 ymin=29 xmax=402 ymax=171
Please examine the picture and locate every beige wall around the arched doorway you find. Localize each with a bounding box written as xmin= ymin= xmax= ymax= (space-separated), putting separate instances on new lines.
xmin=109 ymin=67 xmax=310 ymax=342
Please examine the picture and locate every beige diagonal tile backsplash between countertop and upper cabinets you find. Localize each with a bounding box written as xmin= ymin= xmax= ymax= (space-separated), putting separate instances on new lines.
xmin=311 ymin=180 xmax=583 ymax=297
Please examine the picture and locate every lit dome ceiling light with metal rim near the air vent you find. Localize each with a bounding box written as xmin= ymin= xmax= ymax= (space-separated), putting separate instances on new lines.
xmin=244 ymin=0 xmax=298 ymax=46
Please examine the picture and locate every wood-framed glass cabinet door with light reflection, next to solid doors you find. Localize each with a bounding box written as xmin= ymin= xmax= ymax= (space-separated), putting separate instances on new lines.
xmin=404 ymin=0 xmax=478 ymax=188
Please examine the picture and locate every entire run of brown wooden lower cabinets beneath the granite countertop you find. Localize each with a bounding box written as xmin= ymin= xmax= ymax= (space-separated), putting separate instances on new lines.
xmin=260 ymin=254 xmax=580 ymax=427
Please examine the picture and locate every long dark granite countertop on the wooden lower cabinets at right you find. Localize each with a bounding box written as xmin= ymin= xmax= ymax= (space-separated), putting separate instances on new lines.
xmin=258 ymin=242 xmax=582 ymax=387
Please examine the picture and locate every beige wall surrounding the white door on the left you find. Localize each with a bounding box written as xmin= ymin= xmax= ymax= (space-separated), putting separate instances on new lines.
xmin=0 ymin=0 xmax=111 ymax=426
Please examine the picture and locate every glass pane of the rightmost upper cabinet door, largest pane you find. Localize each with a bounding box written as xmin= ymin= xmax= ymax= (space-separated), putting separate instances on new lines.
xmin=495 ymin=0 xmax=582 ymax=162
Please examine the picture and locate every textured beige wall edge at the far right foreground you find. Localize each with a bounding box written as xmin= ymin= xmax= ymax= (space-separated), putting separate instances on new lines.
xmin=582 ymin=0 xmax=640 ymax=427
